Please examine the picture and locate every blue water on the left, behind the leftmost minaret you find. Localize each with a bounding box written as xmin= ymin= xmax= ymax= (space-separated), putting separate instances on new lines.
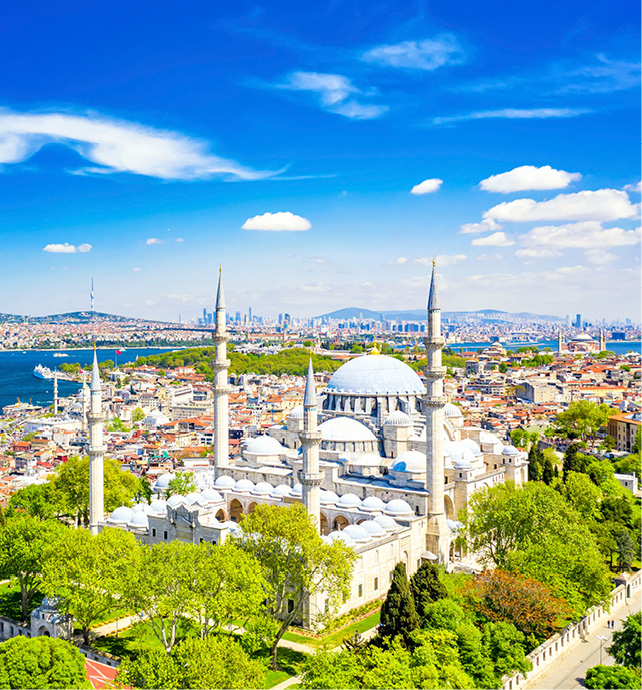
xmin=0 ymin=347 xmax=176 ymax=408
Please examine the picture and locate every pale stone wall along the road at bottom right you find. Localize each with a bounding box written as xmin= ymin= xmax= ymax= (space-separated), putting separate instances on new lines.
xmin=502 ymin=570 xmax=642 ymax=690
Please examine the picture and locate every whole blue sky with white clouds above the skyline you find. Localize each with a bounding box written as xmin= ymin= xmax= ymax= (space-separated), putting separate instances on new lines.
xmin=0 ymin=0 xmax=640 ymax=321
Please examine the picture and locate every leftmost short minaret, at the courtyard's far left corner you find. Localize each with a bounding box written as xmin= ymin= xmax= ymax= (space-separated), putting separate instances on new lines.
xmin=89 ymin=345 xmax=105 ymax=534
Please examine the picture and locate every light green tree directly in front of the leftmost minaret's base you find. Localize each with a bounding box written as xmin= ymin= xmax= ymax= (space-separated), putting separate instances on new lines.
xmin=43 ymin=528 xmax=140 ymax=645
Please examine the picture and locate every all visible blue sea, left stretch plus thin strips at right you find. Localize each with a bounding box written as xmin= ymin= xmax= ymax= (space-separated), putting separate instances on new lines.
xmin=0 ymin=340 xmax=641 ymax=408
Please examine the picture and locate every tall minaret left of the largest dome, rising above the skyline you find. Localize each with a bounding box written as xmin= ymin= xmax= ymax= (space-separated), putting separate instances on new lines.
xmin=212 ymin=268 xmax=230 ymax=477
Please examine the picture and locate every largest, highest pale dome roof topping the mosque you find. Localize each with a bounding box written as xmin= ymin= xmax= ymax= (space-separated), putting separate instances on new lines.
xmin=326 ymin=355 xmax=425 ymax=395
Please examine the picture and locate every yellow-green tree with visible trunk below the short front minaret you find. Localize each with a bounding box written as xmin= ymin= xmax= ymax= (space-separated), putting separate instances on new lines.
xmin=235 ymin=503 xmax=356 ymax=669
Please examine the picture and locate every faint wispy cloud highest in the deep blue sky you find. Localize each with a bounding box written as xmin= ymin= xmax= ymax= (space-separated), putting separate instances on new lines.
xmin=361 ymin=34 xmax=465 ymax=72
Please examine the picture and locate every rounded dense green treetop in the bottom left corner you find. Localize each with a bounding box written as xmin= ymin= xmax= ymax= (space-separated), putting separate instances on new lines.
xmin=0 ymin=635 xmax=91 ymax=690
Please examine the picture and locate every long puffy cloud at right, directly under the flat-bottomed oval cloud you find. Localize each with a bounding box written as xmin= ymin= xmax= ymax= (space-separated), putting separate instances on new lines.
xmin=484 ymin=189 xmax=638 ymax=223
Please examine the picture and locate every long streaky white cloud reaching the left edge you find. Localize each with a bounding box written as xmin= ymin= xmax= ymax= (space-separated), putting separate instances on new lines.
xmin=0 ymin=110 xmax=274 ymax=180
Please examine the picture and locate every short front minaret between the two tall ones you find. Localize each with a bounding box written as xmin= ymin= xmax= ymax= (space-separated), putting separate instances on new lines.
xmin=299 ymin=357 xmax=323 ymax=529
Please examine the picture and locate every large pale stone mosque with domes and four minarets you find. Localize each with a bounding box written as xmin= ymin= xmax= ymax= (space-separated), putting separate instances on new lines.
xmin=89 ymin=265 xmax=528 ymax=626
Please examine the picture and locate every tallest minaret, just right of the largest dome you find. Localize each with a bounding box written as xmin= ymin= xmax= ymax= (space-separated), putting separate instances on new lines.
xmin=424 ymin=259 xmax=449 ymax=563
